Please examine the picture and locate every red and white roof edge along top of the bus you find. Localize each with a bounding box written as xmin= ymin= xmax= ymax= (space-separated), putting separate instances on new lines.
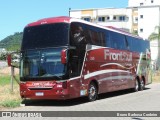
xmin=26 ymin=16 xmax=143 ymax=39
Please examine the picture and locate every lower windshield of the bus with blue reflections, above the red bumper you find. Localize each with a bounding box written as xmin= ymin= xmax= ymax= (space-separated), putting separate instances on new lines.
xmin=20 ymin=48 xmax=66 ymax=80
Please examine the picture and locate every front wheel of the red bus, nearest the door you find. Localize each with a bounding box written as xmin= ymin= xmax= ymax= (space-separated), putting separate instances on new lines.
xmin=88 ymin=82 xmax=98 ymax=101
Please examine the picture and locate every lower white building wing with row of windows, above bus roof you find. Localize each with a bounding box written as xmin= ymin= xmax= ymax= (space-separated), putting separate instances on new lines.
xmin=70 ymin=8 xmax=132 ymax=31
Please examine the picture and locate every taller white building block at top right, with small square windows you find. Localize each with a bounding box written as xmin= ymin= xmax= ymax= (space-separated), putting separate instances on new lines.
xmin=128 ymin=0 xmax=160 ymax=62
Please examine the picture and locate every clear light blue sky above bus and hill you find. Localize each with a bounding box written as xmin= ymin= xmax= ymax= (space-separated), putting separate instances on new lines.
xmin=0 ymin=0 xmax=128 ymax=40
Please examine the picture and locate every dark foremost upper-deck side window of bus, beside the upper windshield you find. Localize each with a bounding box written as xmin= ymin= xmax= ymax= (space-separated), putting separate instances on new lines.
xmin=70 ymin=22 xmax=105 ymax=46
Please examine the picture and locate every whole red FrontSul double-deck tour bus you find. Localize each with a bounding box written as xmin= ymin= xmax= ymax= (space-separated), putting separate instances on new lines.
xmin=20 ymin=17 xmax=150 ymax=101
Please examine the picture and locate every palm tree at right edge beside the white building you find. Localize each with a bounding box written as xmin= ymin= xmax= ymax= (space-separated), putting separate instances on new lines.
xmin=148 ymin=26 xmax=160 ymax=68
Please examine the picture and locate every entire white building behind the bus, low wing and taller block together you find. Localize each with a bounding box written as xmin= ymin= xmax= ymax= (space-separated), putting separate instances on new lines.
xmin=70 ymin=0 xmax=160 ymax=60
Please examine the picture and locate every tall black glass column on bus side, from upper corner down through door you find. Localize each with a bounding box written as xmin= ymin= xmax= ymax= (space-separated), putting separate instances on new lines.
xmin=68 ymin=22 xmax=88 ymax=77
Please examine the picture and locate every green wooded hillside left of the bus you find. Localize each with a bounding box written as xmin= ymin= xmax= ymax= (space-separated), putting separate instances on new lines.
xmin=0 ymin=32 xmax=23 ymax=51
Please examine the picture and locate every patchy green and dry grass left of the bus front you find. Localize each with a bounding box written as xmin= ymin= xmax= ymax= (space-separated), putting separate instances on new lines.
xmin=0 ymin=75 xmax=21 ymax=110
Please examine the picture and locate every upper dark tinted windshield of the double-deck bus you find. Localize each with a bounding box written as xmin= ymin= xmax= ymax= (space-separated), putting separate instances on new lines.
xmin=21 ymin=23 xmax=69 ymax=50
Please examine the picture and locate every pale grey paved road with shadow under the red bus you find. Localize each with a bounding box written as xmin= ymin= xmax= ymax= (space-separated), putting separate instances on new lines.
xmin=7 ymin=83 xmax=160 ymax=120
